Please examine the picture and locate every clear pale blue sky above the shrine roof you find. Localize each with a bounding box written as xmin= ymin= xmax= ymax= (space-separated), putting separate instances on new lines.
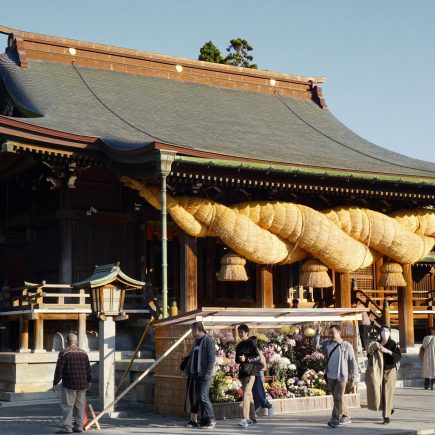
xmin=0 ymin=0 xmax=435 ymax=162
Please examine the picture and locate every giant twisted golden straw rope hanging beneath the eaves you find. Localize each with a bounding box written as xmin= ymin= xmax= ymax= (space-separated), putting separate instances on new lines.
xmin=121 ymin=176 xmax=435 ymax=272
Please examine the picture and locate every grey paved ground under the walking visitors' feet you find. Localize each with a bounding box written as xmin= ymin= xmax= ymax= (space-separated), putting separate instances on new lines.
xmin=0 ymin=388 xmax=435 ymax=435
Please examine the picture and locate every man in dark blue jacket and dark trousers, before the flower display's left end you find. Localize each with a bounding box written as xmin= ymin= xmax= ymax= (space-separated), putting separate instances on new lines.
xmin=184 ymin=322 xmax=216 ymax=429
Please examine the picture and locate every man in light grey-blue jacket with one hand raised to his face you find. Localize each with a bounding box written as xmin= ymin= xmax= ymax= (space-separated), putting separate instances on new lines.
xmin=314 ymin=324 xmax=359 ymax=427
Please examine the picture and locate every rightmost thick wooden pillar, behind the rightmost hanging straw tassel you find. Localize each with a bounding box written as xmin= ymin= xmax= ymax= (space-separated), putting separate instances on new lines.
xmin=398 ymin=264 xmax=414 ymax=352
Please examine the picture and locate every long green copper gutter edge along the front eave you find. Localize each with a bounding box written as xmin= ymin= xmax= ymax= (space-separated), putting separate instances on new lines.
xmin=175 ymin=156 xmax=435 ymax=186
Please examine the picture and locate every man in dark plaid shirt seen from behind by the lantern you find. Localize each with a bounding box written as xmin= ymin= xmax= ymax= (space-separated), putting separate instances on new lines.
xmin=53 ymin=333 xmax=92 ymax=433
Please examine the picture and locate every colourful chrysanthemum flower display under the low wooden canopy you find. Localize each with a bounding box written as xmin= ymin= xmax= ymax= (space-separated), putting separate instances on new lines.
xmin=210 ymin=325 xmax=328 ymax=403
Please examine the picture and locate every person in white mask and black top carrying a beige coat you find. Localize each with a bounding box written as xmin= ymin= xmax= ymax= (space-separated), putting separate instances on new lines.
xmin=366 ymin=325 xmax=402 ymax=424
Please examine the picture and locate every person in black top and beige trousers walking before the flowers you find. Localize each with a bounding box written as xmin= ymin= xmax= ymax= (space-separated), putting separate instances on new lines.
xmin=236 ymin=325 xmax=261 ymax=427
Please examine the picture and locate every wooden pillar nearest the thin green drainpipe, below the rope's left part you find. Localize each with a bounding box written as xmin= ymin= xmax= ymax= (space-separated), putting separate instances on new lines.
xmin=180 ymin=232 xmax=198 ymax=313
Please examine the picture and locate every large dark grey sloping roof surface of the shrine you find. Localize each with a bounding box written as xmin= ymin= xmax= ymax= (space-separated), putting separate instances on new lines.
xmin=0 ymin=54 xmax=435 ymax=177
